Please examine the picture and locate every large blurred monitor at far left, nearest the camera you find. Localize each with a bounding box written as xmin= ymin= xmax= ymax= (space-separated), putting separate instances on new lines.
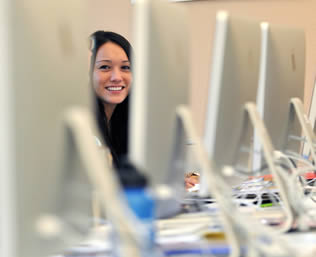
xmin=0 ymin=0 xmax=94 ymax=257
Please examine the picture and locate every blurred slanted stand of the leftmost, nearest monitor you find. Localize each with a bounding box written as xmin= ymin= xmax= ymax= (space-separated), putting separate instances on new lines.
xmin=39 ymin=107 xmax=142 ymax=257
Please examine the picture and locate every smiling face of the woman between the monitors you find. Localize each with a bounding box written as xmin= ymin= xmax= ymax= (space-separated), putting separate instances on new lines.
xmin=92 ymin=42 xmax=132 ymax=105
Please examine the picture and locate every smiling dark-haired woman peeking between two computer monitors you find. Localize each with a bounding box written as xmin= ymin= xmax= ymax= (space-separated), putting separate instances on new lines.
xmin=90 ymin=31 xmax=132 ymax=167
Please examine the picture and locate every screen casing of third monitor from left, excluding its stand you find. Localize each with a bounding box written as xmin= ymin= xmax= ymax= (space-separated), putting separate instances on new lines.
xmin=204 ymin=11 xmax=260 ymax=171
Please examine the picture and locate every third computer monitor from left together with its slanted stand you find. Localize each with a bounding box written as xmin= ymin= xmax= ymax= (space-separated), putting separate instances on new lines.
xmin=202 ymin=12 xmax=302 ymax=234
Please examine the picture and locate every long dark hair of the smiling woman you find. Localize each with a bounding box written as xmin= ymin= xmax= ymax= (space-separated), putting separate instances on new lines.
xmin=90 ymin=31 xmax=132 ymax=167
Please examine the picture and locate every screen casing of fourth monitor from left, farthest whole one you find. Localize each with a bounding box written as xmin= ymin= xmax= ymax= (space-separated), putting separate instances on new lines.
xmin=253 ymin=24 xmax=305 ymax=169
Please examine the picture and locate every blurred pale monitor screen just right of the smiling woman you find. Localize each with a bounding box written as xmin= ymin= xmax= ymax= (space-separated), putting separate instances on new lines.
xmin=129 ymin=0 xmax=190 ymax=189
